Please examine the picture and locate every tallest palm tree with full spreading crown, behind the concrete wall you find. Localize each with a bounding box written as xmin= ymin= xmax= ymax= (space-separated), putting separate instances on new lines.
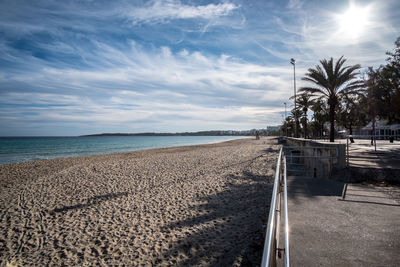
xmin=299 ymin=56 xmax=363 ymax=142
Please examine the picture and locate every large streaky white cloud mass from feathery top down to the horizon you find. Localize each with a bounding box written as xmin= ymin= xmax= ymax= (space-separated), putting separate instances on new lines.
xmin=0 ymin=43 xmax=292 ymax=131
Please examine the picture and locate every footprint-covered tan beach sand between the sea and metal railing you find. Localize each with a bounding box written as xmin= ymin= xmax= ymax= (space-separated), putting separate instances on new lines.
xmin=0 ymin=138 xmax=278 ymax=266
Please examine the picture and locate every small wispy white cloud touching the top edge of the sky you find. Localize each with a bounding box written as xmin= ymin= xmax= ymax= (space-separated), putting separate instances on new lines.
xmin=128 ymin=0 xmax=239 ymax=24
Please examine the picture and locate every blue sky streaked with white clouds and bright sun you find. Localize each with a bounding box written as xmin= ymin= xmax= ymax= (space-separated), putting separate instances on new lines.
xmin=0 ymin=0 xmax=400 ymax=136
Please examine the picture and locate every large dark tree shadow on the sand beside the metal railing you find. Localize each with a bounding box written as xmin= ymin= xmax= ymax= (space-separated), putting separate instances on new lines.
xmin=159 ymin=171 xmax=272 ymax=266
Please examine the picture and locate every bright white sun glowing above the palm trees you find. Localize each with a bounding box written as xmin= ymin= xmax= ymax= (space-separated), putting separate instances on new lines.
xmin=338 ymin=4 xmax=369 ymax=38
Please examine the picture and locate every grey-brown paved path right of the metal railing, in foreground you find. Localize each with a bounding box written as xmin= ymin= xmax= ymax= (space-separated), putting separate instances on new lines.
xmin=288 ymin=176 xmax=400 ymax=266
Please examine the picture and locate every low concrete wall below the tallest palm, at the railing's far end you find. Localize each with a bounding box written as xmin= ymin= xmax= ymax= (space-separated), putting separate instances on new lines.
xmin=283 ymin=137 xmax=346 ymax=177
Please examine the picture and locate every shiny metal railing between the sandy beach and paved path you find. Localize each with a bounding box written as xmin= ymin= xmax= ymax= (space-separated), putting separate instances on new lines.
xmin=261 ymin=148 xmax=290 ymax=267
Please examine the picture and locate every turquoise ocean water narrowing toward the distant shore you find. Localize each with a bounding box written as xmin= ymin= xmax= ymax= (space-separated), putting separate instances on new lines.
xmin=0 ymin=136 xmax=243 ymax=164
